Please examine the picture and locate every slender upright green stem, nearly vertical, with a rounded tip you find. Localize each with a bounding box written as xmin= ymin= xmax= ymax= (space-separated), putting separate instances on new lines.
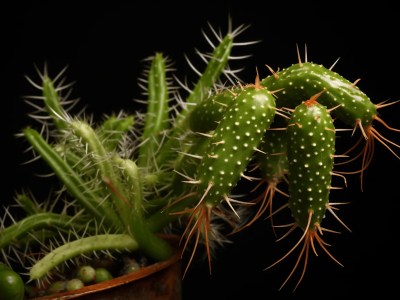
xmin=138 ymin=53 xmax=170 ymax=167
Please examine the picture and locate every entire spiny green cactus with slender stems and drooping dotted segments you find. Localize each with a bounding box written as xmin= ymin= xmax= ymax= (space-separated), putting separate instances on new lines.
xmin=0 ymin=18 xmax=400 ymax=298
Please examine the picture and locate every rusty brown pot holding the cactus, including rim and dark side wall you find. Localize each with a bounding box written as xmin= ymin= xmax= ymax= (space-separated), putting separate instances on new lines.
xmin=31 ymin=235 xmax=182 ymax=300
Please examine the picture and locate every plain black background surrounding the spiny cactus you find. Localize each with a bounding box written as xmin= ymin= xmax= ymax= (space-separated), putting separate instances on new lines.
xmin=0 ymin=0 xmax=400 ymax=300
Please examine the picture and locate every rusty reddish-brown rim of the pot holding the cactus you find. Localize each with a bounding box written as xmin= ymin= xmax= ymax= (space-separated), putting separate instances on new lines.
xmin=28 ymin=234 xmax=181 ymax=300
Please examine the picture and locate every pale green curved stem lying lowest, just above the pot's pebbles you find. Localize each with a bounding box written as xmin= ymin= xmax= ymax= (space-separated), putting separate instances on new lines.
xmin=29 ymin=234 xmax=139 ymax=280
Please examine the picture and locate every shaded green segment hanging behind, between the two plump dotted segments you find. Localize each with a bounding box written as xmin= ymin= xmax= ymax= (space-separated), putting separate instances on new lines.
xmin=256 ymin=129 xmax=289 ymax=182
